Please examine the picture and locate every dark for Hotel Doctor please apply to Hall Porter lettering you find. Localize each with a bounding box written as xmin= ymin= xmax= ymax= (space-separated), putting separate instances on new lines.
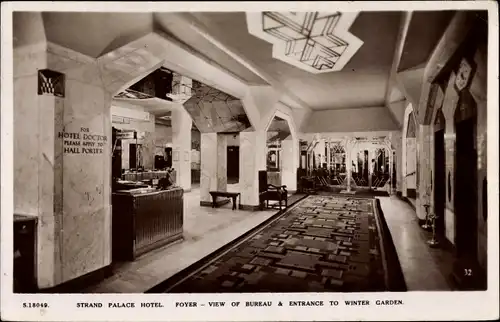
xmin=57 ymin=127 xmax=108 ymax=154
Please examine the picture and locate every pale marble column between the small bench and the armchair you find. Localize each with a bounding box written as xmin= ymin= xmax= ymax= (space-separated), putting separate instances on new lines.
xmin=239 ymin=131 xmax=267 ymax=210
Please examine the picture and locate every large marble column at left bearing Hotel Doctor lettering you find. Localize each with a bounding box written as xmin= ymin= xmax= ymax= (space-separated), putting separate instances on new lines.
xmin=14 ymin=43 xmax=112 ymax=289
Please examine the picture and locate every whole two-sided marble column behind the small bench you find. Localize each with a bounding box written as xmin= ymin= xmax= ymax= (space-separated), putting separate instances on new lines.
xmin=200 ymin=133 xmax=227 ymax=206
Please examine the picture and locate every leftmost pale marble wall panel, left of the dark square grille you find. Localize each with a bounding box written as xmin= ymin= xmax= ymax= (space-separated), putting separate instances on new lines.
xmin=13 ymin=74 xmax=43 ymax=215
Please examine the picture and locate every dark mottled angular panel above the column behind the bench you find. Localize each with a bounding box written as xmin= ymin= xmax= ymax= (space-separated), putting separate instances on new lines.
xmin=184 ymin=80 xmax=251 ymax=133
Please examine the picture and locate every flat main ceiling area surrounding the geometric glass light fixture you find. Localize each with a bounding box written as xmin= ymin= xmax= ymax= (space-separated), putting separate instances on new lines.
xmin=184 ymin=12 xmax=402 ymax=109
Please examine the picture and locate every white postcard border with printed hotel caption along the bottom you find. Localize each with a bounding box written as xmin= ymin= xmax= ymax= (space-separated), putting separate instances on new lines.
xmin=1 ymin=1 xmax=499 ymax=321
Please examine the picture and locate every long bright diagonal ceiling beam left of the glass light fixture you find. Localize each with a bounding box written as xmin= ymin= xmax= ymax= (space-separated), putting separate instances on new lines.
xmin=174 ymin=14 xmax=311 ymax=109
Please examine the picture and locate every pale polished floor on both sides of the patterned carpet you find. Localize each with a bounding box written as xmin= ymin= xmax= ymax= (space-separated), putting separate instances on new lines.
xmin=84 ymin=184 xmax=454 ymax=293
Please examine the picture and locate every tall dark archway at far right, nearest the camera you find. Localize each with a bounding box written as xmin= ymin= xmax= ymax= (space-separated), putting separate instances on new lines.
xmin=454 ymin=90 xmax=478 ymax=261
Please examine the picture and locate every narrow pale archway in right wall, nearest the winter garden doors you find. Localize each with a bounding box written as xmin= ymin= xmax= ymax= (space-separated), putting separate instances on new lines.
xmin=401 ymin=104 xmax=417 ymax=199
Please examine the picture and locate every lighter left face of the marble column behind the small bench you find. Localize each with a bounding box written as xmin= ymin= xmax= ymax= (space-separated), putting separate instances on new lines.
xmin=200 ymin=133 xmax=217 ymax=202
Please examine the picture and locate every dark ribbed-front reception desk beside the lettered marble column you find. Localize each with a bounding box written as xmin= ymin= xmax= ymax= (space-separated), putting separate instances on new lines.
xmin=112 ymin=188 xmax=184 ymax=261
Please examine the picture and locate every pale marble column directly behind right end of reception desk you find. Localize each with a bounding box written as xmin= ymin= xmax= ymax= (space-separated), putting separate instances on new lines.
xmin=172 ymin=106 xmax=191 ymax=191
